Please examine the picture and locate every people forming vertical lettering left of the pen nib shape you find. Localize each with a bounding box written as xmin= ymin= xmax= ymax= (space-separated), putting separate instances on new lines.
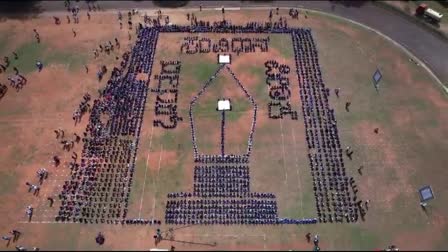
xmin=151 ymin=61 xmax=182 ymax=129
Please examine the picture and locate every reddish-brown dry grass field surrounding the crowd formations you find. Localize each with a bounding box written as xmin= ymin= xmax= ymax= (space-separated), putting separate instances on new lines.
xmin=0 ymin=6 xmax=448 ymax=250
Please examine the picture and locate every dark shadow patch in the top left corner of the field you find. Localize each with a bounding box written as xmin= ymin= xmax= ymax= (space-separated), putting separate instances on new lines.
xmin=0 ymin=0 xmax=43 ymax=21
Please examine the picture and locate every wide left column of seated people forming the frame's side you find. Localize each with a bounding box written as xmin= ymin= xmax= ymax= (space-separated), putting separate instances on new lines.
xmin=56 ymin=29 xmax=161 ymax=225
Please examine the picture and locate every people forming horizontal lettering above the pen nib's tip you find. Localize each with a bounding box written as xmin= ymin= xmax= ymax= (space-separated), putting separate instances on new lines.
xmin=180 ymin=36 xmax=269 ymax=55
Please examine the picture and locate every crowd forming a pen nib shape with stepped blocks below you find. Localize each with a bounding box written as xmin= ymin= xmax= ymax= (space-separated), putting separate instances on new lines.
xmin=165 ymin=64 xmax=317 ymax=225
